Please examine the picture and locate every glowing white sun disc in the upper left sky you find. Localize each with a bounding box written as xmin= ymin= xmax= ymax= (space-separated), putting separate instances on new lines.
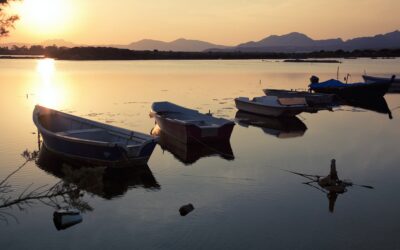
xmin=20 ymin=0 xmax=71 ymax=34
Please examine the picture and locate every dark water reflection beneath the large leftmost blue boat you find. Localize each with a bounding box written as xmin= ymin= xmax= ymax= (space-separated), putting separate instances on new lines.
xmin=37 ymin=146 xmax=160 ymax=199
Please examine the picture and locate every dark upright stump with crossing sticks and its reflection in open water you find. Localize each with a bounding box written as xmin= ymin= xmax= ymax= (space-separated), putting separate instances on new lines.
xmin=288 ymin=159 xmax=373 ymax=213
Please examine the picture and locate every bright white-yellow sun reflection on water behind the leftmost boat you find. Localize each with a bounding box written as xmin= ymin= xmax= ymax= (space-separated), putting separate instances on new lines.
xmin=36 ymin=59 xmax=64 ymax=108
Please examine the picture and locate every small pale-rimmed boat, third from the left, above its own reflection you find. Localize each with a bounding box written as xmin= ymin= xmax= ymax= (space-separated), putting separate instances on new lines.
xmin=235 ymin=96 xmax=308 ymax=117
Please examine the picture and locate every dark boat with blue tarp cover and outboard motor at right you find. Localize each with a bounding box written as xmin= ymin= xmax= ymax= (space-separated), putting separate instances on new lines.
xmin=309 ymin=74 xmax=394 ymax=98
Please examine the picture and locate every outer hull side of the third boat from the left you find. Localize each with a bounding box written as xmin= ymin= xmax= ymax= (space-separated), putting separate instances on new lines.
xmin=235 ymin=99 xmax=305 ymax=117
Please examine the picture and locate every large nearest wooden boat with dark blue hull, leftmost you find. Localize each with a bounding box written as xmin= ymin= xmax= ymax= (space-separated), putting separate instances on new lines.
xmin=33 ymin=105 xmax=158 ymax=166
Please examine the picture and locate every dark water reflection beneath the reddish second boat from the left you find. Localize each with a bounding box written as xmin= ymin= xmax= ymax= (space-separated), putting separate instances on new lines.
xmin=151 ymin=125 xmax=235 ymax=165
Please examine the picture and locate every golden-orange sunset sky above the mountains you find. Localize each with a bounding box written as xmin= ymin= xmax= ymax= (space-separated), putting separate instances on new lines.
xmin=1 ymin=0 xmax=400 ymax=45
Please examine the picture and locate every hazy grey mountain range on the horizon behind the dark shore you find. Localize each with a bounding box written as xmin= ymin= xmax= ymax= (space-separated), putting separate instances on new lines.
xmin=0 ymin=30 xmax=400 ymax=52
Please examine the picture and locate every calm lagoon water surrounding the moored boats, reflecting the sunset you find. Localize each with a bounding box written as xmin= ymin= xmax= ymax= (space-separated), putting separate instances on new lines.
xmin=0 ymin=59 xmax=400 ymax=249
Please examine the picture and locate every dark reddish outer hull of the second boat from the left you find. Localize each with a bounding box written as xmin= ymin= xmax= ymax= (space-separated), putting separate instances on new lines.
xmin=155 ymin=114 xmax=235 ymax=143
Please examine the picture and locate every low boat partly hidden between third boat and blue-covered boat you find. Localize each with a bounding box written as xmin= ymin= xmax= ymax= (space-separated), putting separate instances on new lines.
xmin=263 ymin=89 xmax=335 ymax=106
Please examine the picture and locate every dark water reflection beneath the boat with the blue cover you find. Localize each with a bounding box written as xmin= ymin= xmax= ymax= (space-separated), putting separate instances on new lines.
xmin=340 ymin=97 xmax=393 ymax=119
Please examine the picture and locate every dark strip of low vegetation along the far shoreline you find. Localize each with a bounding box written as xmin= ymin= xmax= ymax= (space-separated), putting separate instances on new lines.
xmin=0 ymin=46 xmax=400 ymax=60
